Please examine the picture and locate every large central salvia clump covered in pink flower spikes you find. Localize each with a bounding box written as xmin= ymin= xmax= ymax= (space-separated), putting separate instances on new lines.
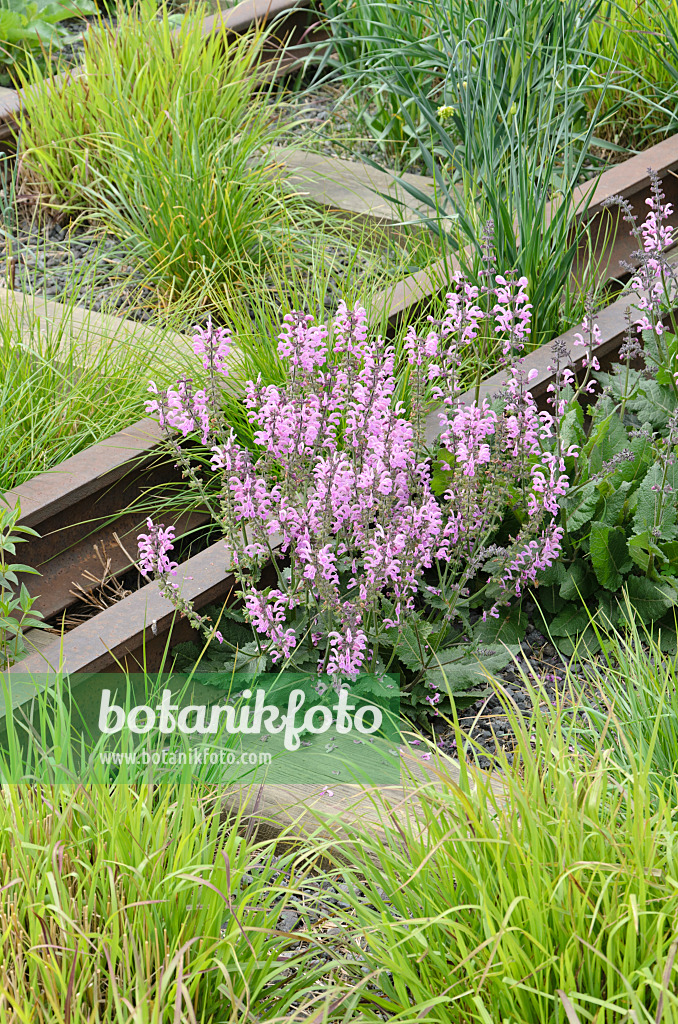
xmin=141 ymin=264 xmax=577 ymax=705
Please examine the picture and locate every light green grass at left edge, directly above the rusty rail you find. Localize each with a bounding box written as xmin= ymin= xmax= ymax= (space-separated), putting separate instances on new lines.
xmin=0 ymin=282 xmax=183 ymax=492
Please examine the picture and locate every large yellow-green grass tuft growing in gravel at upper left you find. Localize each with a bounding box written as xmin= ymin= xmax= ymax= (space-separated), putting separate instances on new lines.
xmin=19 ymin=0 xmax=313 ymax=304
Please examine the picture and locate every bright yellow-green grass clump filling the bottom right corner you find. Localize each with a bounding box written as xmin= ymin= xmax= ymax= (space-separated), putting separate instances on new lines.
xmin=307 ymin=671 xmax=678 ymax=1024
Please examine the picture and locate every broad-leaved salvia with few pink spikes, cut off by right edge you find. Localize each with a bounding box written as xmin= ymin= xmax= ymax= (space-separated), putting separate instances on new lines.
xmin=528 ymin=167 xmax=678 ymax=653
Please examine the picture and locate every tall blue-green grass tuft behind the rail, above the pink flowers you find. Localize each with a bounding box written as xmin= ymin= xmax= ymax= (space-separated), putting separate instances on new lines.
xmin=321 ymin=0 xmax=599 ymax=348
